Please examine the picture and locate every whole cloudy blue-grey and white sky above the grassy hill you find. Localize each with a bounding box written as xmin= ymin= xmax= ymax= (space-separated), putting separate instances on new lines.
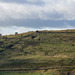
xmin=0 ymin=0 xmax=75 ymax=35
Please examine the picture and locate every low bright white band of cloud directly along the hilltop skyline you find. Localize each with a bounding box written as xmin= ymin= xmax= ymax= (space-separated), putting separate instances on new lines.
xmin=0 ymin=22 xmax=74 ymax=35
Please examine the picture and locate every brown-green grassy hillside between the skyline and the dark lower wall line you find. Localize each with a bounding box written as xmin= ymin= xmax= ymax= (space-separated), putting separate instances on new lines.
xmin=0 ymin=30 xmax=75 ymax=68
